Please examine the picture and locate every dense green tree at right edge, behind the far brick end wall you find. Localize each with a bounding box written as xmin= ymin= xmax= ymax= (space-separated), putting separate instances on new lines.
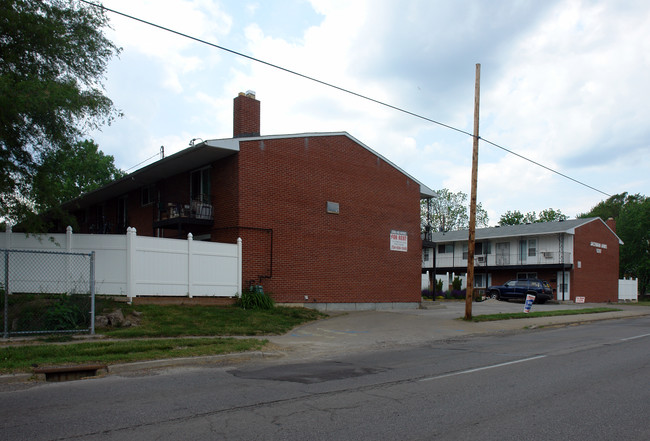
xmin=579 ymin=193 xmax=650 ymax=294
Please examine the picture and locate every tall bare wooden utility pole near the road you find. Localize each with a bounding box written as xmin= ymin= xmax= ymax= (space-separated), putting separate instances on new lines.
xmin=465 ymin=63 xmax=481 ymax=320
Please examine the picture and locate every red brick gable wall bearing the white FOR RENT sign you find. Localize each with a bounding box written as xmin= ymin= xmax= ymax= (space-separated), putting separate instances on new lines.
xmin=239 ymin=136 xmax=421 ymax=303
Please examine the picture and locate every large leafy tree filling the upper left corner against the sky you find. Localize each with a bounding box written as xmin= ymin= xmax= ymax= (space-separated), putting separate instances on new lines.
xmin=0 ymin=0 xmax=119 ymax=225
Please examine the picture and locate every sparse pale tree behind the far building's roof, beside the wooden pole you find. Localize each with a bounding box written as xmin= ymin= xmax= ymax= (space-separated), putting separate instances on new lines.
xmin=420 ymin=188 xmax=488 ymax=231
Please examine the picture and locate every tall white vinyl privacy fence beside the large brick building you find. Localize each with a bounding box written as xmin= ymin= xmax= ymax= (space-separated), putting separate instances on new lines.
xmin=4 ymin=227 xmax=242 ymax=298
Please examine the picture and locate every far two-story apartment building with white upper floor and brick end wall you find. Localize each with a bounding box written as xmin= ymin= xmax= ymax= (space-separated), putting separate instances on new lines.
xmin=422 ymin=217 xmax=623 ymax=302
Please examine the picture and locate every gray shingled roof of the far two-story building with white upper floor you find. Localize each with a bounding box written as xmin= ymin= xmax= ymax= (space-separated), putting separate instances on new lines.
xmin=431 ymin=217 xmax=620 ymax=243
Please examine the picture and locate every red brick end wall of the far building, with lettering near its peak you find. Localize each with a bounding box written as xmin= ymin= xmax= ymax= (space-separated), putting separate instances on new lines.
xmin=570 ymin=220 xmax=619 ymax=302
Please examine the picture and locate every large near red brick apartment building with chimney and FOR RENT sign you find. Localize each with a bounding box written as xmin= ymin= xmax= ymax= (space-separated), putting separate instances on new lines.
xmin=66 ymin=93 xmax=432 ymax=307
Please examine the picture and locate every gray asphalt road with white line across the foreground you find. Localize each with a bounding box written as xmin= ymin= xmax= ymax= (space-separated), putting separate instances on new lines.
xmin=0 ymin=317 xmax=650 ymax=441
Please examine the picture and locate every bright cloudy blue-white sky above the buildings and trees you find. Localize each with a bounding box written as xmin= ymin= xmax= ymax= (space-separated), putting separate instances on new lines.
xmin=91 ymin=0 xmax=650 ymax=225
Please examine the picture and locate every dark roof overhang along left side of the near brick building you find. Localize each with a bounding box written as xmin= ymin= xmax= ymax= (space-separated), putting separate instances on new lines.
xmin=63 ymin=140 xmax=239 ymax=210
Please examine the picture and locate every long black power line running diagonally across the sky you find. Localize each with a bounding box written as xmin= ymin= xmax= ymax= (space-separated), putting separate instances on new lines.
xmin=80 ymin=0 xmax=611 ymax=197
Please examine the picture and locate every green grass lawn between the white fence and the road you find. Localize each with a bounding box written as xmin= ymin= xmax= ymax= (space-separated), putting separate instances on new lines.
xmin=0 ymin=302 xmax=326 ymax=373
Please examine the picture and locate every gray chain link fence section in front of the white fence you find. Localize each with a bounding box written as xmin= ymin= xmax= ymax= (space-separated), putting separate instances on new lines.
xmin=0 ymin=249 xmax=95 ymax=338
